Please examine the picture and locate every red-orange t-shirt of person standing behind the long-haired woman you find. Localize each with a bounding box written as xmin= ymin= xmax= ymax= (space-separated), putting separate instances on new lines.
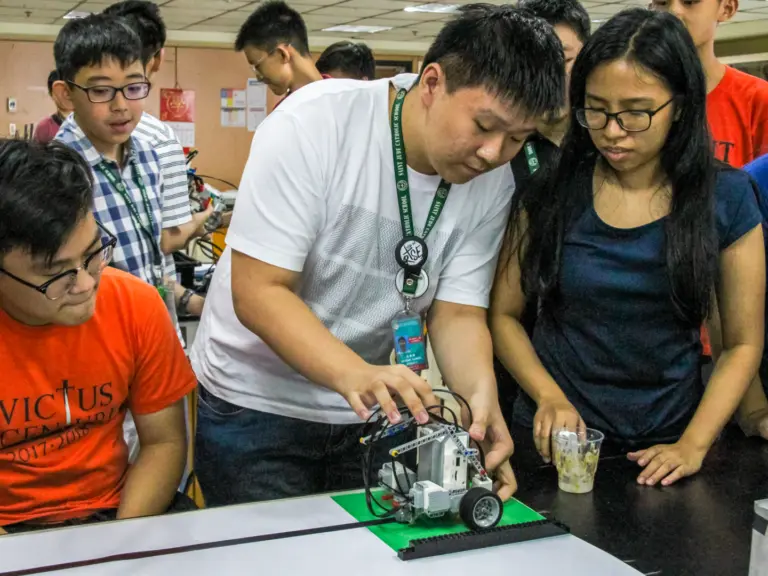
xmin=707 ymin=66 xmax=768 ymax=168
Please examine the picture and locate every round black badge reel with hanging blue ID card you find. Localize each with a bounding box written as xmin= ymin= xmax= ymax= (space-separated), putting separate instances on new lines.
xmin=392 ymin=237 xmax=429 ymax=374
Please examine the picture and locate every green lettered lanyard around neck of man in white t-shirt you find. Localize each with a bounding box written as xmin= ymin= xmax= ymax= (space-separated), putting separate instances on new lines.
xmin=392 ymin=90 xmax=451 ymax=296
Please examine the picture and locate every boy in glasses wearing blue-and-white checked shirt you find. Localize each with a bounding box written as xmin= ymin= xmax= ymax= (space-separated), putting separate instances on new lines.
xmin=53 ymin=14 xmax=163 ymax=286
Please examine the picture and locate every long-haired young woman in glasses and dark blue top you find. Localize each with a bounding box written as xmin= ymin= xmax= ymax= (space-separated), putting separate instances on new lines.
xmin=490 ymin=9 xmax=765 ymax=486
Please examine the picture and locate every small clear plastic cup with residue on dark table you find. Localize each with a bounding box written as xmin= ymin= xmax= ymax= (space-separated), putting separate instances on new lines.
xmin=552 ymin=428 xmax=605 ymax=494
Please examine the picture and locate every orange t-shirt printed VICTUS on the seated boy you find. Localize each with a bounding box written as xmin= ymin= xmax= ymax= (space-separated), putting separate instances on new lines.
xmin=0 ymin=268 xmax=196 ymax=526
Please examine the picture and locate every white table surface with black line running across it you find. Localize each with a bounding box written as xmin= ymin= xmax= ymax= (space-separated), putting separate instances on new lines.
xmin=0 ymin=496 xmax=640 ymax=576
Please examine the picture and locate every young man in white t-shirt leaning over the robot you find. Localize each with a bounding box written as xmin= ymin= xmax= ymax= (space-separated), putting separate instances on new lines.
xmin=190 ymin=6 xmax=564 ymax=506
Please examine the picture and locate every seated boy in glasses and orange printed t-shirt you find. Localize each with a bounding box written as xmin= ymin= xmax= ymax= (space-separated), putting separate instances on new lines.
xmin=0 ymin=140 xmax=196 ymax=533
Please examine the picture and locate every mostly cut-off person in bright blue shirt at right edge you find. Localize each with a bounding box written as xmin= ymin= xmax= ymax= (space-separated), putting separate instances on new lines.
xmin=739 ymin=154 xmax=768 ymax=439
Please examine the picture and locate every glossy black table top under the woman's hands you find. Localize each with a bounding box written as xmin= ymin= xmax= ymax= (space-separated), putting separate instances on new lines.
xmin=512 ymin=428 xmax=768 ymax=576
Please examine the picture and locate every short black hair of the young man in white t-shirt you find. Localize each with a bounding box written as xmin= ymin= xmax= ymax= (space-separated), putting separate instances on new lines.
xmin=422 ymin=4 xmax=565 ymax=116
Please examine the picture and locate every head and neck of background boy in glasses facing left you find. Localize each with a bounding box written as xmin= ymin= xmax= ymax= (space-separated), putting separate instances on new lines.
xmin=235 ymin=0 xmax=323 ymax=96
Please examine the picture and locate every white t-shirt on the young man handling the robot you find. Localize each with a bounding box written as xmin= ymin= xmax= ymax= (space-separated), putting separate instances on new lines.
xmin=190 ymin=75 xmax=514 ymax=424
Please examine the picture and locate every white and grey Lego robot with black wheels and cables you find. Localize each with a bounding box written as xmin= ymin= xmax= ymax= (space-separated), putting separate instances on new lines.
xmin=360 ymin=415 xmax=504 ymax=530
